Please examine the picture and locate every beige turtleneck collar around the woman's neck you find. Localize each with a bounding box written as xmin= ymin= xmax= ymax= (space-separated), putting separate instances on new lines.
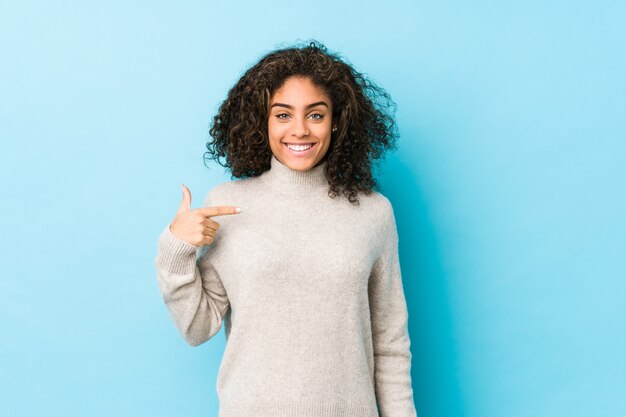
xmin=261 ymin=154 xmax=328 ymax=194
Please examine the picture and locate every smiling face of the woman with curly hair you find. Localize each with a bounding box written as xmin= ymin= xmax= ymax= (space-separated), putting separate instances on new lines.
xmin=267 ymin=77 xmax=333 ymax=171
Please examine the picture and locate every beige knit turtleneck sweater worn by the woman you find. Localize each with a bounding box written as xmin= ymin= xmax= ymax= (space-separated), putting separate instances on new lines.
xmin=155 ymin=156 xmax=416 ymax=417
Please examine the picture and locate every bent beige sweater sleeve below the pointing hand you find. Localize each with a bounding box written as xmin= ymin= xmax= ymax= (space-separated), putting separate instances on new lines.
xmin=154 ymin=188 xmax=230 ymax=346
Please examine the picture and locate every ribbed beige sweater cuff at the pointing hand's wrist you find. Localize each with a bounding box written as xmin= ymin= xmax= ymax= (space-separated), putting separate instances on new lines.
xmin=155 ymin=224 xmax=199 ymax=274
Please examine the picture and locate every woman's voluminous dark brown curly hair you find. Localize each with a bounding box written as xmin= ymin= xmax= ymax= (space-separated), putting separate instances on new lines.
xmin=204 ymin=41 xmax=398 ymax=205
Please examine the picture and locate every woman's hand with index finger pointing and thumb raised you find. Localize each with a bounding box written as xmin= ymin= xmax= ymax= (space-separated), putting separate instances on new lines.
xmin=169 ymin=184 xmax=241 ymax=247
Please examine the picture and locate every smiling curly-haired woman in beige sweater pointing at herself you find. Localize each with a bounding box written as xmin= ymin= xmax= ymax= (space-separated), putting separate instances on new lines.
xmin=155 ymin=42 xmax=416 ymax=417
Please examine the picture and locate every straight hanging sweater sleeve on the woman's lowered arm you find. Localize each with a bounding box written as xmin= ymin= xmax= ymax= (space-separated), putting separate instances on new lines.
xmin=368 ymin=200 xmax=417 ymax=417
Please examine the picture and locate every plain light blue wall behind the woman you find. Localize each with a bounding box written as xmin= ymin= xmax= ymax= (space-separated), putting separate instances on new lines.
xmin=0 ymin=1 xmax=626 ymax=417
